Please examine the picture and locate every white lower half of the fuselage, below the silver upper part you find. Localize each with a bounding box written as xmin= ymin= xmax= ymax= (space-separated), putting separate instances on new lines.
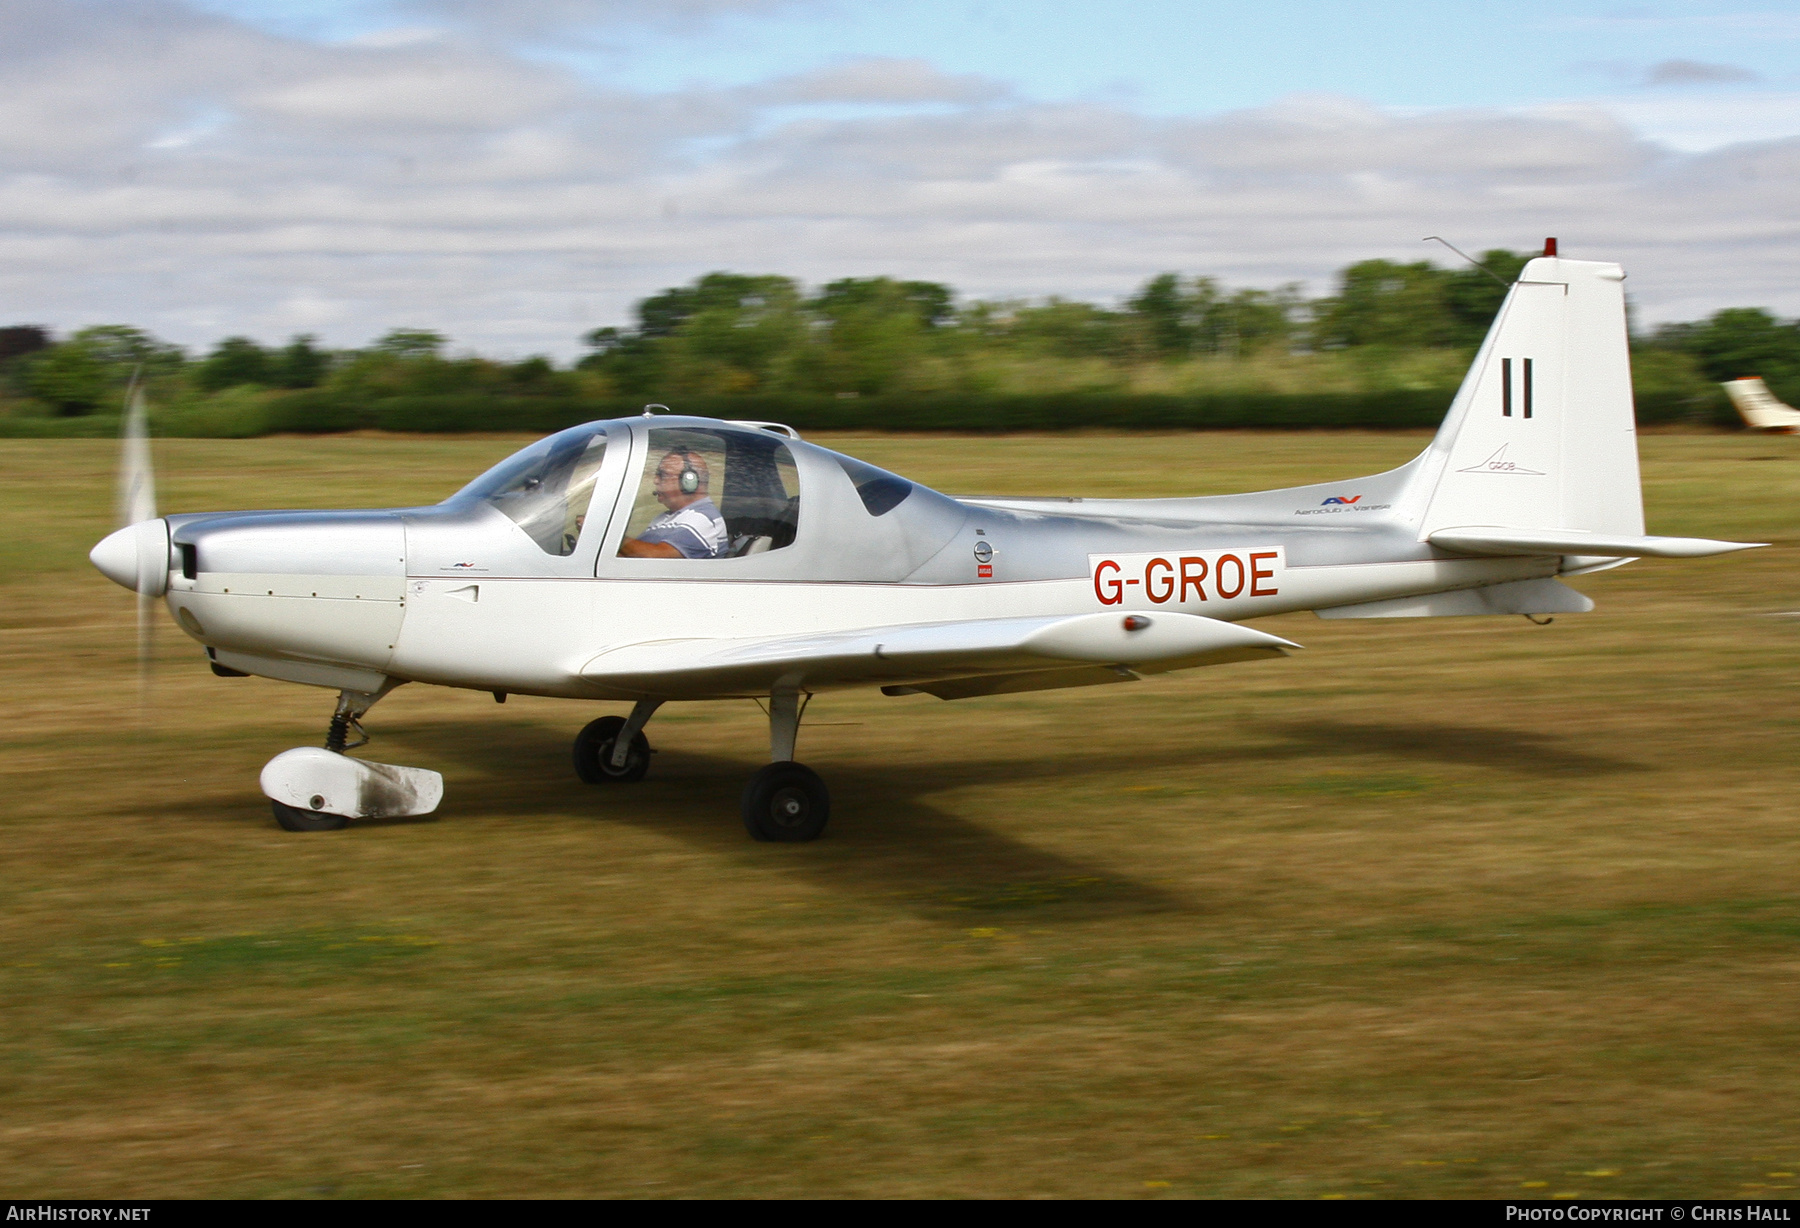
xmin=167 ymin=542 xmax=1561 ymax=699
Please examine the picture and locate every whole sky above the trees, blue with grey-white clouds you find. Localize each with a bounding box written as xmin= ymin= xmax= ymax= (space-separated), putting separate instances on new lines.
xmin=10 ymin=0 xmax=1800 ymax=358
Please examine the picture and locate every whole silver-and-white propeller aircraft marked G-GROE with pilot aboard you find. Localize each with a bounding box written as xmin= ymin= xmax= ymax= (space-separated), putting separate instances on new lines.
xmin=92 ymin=248 xmax=1750 ymax=841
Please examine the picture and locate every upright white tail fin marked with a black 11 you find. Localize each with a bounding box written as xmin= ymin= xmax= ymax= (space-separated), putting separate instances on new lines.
xmin=1406 ymin=256 xmax=1643 ymax=540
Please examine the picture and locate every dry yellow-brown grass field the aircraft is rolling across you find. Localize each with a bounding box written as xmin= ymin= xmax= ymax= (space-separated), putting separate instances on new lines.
xmin=0 ymin=434 xmax=1800 ymax=1197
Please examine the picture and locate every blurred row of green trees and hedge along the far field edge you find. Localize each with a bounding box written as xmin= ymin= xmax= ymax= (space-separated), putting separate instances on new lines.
xmin=0 ymin=250 xmax=1800 ymax=434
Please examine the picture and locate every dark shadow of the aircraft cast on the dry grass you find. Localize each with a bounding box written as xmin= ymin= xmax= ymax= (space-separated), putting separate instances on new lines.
xmin=204 ymin=720 xmax=1642 ymax=920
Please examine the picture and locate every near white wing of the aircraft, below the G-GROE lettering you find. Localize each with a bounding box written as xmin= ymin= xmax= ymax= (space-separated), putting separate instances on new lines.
xmin=581 ymin=612 xmax=1298 ymax=699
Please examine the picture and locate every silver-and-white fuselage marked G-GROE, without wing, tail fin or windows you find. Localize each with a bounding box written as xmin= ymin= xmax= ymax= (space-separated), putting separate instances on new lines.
xmin=154 ymin=408 xmax=1591 ymax=699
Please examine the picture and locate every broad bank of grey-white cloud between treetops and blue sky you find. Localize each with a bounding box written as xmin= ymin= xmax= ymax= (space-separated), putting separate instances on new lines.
xmin=0 ymin=0 xmax=1800 ymax=355
